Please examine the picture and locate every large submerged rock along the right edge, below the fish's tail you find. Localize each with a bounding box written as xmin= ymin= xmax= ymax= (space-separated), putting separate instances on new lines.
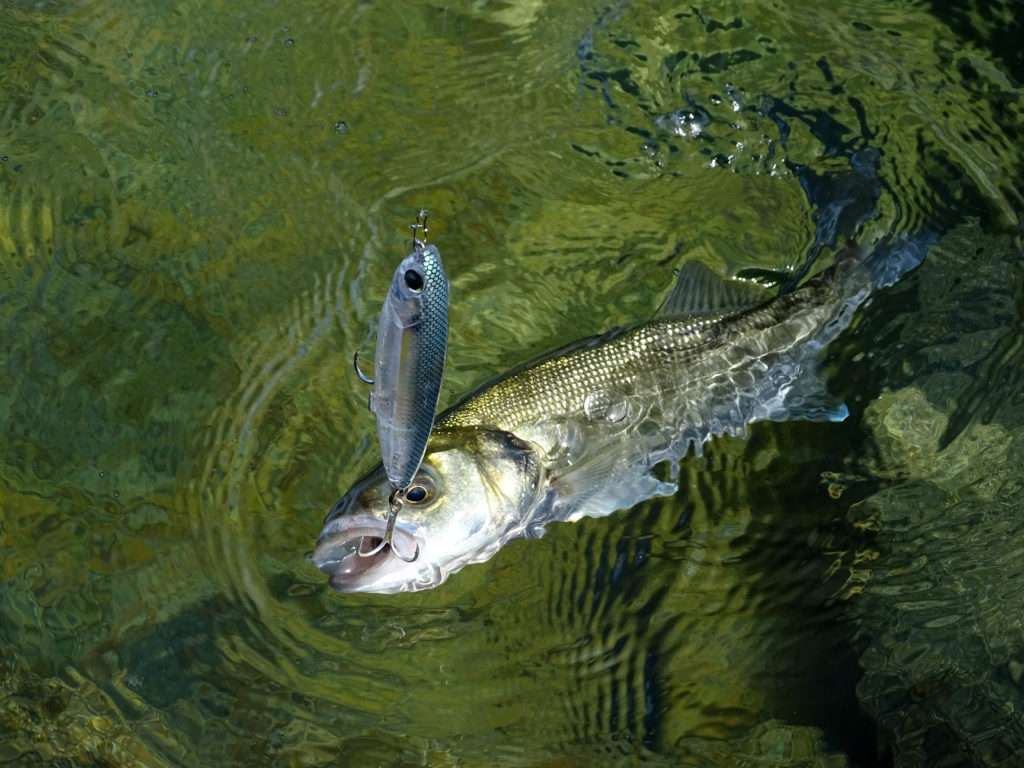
xmin=850 ymin=226 xmax=1024 ymax=768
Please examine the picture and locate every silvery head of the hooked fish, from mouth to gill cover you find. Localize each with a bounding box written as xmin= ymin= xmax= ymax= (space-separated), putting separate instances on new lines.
xmin=312 ymin=427 xmax=543 ymax=593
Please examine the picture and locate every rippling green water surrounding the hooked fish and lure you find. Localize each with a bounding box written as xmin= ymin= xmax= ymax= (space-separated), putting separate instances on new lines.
xmin=0 ymin=0 xmax=1024 ymax=767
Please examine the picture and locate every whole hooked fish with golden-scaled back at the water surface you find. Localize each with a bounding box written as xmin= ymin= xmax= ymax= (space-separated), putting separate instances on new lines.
xmin=311 ymin=236 xmax=931 ymax=594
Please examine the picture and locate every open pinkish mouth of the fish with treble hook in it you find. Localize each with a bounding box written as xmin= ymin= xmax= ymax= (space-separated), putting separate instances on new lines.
xmin=311 ymin=515 xmax=420 ymax=592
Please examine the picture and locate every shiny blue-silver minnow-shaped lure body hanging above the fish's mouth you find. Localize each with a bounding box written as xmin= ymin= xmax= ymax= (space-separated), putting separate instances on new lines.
xmin=370 ymin=245 xmax=449 ymax=488
